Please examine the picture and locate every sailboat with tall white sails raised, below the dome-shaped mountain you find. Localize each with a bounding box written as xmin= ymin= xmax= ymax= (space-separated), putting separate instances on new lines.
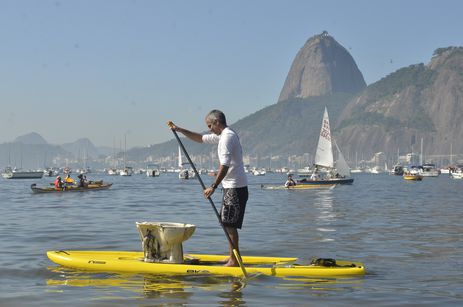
xmin=299 ymin=107 xmax=354 ymax=184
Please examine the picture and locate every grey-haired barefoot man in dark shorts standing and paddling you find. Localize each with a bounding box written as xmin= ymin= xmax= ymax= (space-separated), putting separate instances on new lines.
xmin=168 ymin=110 xmax=249 ymax=266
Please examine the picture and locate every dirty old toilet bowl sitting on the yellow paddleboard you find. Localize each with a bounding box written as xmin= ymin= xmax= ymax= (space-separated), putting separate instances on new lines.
xmin=136 ymin=222 xmax=196 ymax=263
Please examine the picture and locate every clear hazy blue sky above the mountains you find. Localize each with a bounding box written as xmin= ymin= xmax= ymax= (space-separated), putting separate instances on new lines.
xmin=0 ymin=0 xmax=463 ymax=148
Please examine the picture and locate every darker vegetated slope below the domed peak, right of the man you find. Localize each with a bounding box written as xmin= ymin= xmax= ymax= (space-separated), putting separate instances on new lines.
xmin=237 ymin=94 xmax=352 ymax=155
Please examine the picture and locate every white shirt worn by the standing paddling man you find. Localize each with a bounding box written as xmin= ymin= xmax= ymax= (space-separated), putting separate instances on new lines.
xmin=202 ymin=127 xmax=248 ymax=189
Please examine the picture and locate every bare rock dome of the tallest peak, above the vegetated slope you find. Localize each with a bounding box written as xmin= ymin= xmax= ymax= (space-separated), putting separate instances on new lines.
xmin=278 ymin=31 xmax=366 ymax=102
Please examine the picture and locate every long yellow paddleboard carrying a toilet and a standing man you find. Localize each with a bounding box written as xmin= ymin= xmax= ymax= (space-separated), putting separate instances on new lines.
xmin=47 ymin=251 xmax=365 ymax=277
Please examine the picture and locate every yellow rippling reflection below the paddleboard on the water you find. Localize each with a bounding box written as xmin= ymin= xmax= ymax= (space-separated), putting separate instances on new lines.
xmin=47 ymin=267 xmax=364 ymax=306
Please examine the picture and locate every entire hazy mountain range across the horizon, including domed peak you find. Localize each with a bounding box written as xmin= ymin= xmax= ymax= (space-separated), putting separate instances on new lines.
xmin=0 ymin=32 xmax=463 ymax=170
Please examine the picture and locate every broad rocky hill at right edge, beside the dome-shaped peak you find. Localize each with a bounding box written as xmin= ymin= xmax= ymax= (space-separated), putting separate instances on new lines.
xmin=336 ymin=47 xmax=463 ymax=160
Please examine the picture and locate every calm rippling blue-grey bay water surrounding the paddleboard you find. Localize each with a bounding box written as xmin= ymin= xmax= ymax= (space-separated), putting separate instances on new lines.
xmin=0 ymin=174 xmax=463 ymax=306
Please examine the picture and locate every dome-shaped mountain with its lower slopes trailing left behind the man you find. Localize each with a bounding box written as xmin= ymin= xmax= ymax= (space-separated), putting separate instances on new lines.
xmin=128 ymin=32 xmax=366 ymax=165
